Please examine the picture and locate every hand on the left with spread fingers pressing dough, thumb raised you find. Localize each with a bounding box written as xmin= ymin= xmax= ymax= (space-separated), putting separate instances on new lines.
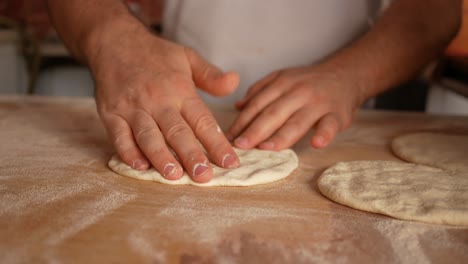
xmin=88 ymin=30 xmax=239 ymax=183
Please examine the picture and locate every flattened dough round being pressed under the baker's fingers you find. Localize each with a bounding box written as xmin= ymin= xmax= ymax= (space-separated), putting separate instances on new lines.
xmin=108 ymin=149 xmax=298 ymax=186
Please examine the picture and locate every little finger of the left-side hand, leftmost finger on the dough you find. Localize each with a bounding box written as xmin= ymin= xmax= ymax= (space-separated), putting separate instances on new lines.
xmin=101 ymin=114 xmax=150 ymax=170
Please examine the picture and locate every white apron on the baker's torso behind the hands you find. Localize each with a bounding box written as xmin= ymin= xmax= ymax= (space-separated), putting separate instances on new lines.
xmin=163 ymin=0 xmax=385 ymax=104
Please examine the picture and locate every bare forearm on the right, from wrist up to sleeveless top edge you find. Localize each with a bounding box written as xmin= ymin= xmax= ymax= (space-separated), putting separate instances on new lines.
xmin=324 ymin=0 xmax=461 ymax=101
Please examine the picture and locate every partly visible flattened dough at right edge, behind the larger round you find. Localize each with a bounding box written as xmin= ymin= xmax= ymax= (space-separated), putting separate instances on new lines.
xmin=392 ymin=132 xmax=468 ymax=172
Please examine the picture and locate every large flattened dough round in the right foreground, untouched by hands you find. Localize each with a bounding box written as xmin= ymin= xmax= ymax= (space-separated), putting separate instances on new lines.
xmin=318 ymin=161 xmax=468 ymax=226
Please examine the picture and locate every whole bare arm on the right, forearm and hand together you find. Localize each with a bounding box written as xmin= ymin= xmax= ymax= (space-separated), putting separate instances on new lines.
xmin=228 ymin=0 xmax=461 ymax=150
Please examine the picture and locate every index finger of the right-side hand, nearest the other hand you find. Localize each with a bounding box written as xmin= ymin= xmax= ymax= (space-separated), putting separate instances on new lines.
xmin=226 ymin=82 xmax=285 ymax=142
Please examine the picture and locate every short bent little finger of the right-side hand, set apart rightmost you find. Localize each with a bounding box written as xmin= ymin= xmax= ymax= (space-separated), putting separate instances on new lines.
xmin=310 ymin=113 xmax=341 ymax=148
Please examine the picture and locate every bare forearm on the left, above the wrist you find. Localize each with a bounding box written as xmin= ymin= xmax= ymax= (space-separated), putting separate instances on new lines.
xmin=47 ymin=0 xmax=145 ymax=64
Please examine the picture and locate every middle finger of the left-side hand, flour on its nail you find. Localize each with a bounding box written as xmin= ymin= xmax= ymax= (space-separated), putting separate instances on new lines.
xmin=154 ymin=108 xmax=213 ymax=183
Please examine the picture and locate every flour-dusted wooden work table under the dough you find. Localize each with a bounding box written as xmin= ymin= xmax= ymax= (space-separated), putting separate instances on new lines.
xmin=0 ymin=97 xmax=468 ymax=263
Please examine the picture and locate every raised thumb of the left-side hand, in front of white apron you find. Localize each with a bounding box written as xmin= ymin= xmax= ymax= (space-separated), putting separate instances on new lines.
xmin=185 ymin=48 xmax=239 ymax=96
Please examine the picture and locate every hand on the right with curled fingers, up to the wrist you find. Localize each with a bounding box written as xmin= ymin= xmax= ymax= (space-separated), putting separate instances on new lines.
xmin=227 ymin=65 xmax=364 ymax=150
